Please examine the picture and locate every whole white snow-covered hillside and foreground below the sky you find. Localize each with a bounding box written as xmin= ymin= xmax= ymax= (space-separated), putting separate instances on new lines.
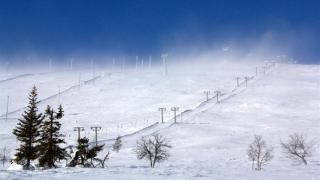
xmin=0 ymin=62 xmax=320 ymax=180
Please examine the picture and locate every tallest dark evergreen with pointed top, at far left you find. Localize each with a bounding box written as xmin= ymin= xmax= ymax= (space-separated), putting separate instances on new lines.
xmin=13 ymin=86 xmax=44 ymax=169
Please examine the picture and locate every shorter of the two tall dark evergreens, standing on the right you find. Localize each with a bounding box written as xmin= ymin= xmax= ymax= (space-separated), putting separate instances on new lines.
xmin=39 ymin=105 xmax=66 ymax=168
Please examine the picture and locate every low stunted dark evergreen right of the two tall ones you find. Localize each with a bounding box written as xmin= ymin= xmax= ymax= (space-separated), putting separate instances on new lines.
xmin=69 ymin=137 xmax=104 ymax=167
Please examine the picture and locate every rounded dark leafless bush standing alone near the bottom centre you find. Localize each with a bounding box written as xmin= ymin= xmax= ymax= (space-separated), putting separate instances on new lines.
xmin=135 ymin=134 xmax=172 ymax=168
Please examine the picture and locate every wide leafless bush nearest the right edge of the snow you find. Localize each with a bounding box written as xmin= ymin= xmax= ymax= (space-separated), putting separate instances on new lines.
xmin=281 ymin=133 xmax=313 ymax=165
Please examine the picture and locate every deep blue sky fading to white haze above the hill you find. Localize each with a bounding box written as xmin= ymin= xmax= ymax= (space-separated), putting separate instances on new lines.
xmin=0 ymin=0 xmax=320 ymax=63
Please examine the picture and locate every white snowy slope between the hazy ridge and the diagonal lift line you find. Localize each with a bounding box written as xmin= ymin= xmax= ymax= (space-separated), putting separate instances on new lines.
xmin=0 ymin=62 xmax=256 ymax=146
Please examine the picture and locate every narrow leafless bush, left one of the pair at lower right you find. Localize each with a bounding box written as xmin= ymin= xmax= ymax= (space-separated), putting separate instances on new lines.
xmin=247 ymin=135 xmax=273 ymax=171
